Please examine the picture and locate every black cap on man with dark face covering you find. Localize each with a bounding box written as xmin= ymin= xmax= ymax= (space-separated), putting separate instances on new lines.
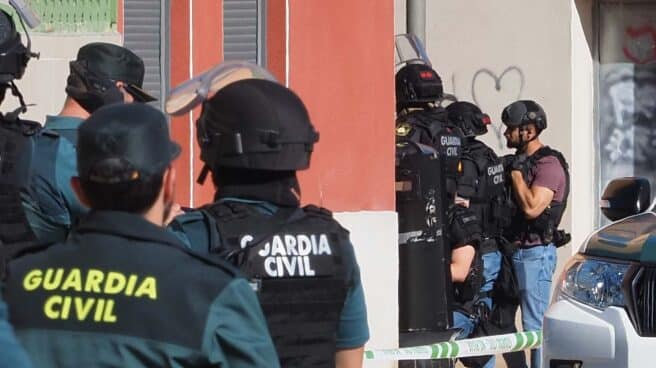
xmin=75 ymin=42 xmax=156 ymax=102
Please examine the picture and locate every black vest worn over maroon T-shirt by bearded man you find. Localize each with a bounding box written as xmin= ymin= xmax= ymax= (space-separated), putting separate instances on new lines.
xmin=513 ymin=146 xmax=570 ymax=246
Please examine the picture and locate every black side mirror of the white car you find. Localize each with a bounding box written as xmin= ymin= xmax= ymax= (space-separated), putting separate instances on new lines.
xmin=599 ymin=177 xmax=651 ymax=221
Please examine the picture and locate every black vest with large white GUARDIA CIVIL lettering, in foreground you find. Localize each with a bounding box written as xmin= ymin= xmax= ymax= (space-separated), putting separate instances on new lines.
xmin=202 ymin=201 xmax=350 ymax=367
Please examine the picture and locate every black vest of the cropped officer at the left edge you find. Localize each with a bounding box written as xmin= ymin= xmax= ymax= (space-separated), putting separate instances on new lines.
xmin=0 ymin=117 xmax=41 ymax=245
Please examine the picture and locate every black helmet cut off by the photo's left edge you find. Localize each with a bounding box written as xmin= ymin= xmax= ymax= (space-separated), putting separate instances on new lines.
xmin=0 ymin=10 xmax=31 ymax=84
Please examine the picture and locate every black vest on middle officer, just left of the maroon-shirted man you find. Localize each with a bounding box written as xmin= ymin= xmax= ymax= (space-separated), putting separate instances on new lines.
xmin=458 ymin=140 xmax=512 ymax=242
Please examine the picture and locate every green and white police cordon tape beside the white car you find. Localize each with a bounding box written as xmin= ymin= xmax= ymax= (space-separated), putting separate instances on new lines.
xmin=364 ymin=331 xmax=542 ymax=360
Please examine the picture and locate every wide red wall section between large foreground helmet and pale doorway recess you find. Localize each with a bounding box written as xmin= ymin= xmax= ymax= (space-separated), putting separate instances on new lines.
xmin=289 ymin=0 xmax=394 ymax=211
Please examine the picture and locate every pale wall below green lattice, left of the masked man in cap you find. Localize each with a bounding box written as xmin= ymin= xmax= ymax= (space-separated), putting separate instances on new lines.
xmin=2 ymin=33 xmax=122 ymax=123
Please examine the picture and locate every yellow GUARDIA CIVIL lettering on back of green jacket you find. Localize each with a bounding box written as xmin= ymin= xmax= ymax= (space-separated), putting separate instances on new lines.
xmin=23 ymin=268 xmax=157 ymax=323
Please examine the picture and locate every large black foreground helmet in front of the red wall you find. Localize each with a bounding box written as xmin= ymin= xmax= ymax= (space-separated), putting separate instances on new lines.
xmin=196 ymin=79 xmax=319 ymax=172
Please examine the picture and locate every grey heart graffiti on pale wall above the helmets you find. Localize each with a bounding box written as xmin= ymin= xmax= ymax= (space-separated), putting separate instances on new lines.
xmin=471 ymin=65 xmax=525 ymax=149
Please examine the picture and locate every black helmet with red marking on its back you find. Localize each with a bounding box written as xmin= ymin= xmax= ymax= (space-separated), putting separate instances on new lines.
xmin=396 ymin=64 xmax=444 ymax=112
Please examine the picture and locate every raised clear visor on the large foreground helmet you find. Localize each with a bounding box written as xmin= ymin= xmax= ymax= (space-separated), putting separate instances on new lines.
xmin=165 ymin=61 xmax=276 ymax=115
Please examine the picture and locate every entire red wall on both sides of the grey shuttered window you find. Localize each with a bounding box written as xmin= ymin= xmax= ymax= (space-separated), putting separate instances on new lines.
xmin=171 ymin=0 xmax=394 ymax=211
